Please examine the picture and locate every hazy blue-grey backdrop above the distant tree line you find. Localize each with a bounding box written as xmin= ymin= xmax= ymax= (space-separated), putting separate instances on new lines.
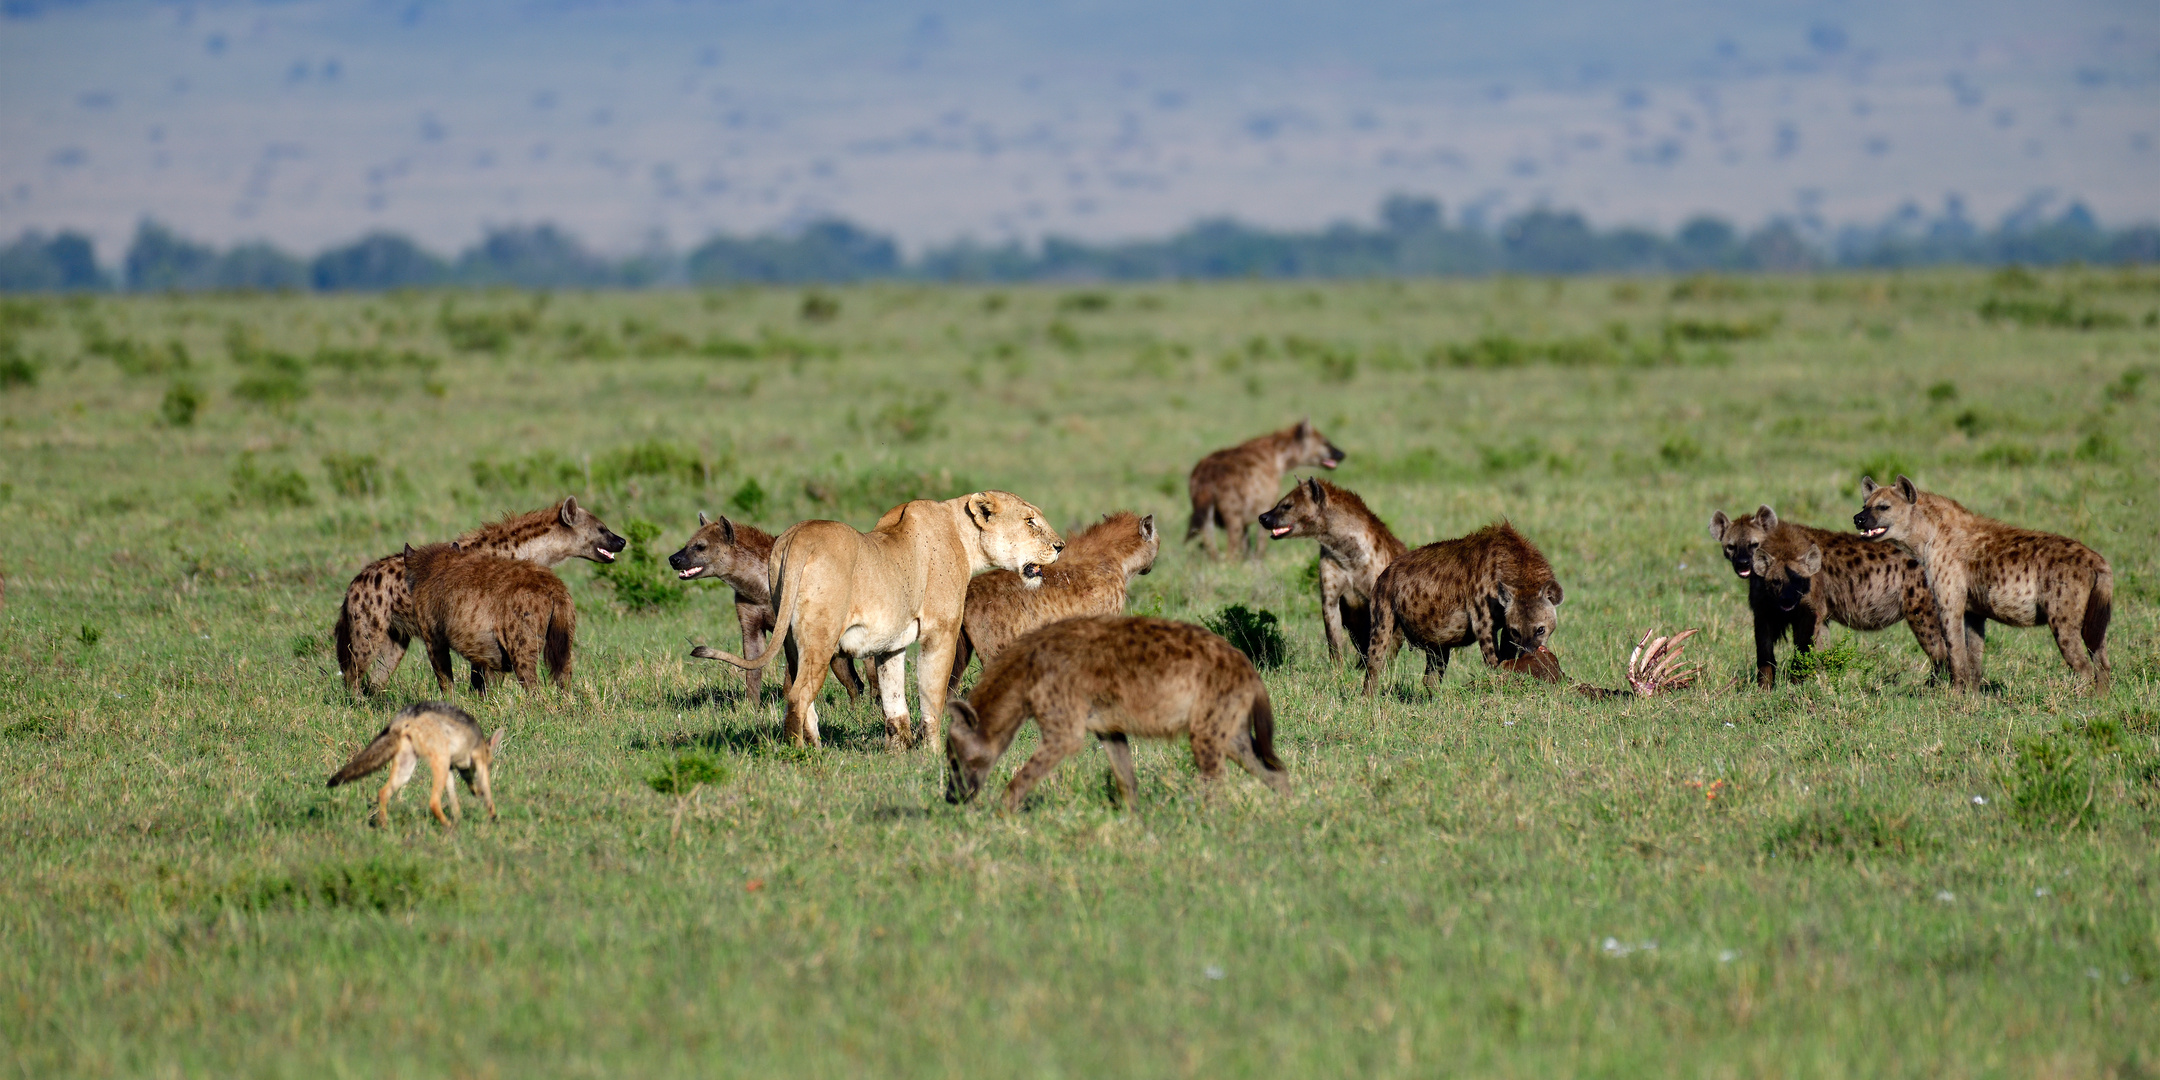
xmin=0 ymin=0 xmax=2160 ymax=257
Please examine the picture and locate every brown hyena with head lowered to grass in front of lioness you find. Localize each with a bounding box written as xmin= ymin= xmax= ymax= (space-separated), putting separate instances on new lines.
xmin=946 ymin=616 xmax=1290 ymax=810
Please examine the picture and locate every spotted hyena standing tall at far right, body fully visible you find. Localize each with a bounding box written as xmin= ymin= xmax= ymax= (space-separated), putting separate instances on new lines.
xmin=1853 ymin=477 xmax=2115 ymax=693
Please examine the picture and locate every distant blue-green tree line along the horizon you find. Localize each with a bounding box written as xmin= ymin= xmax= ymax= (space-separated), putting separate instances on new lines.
xmin=0 ymin=194 xmax=2160 ymax=292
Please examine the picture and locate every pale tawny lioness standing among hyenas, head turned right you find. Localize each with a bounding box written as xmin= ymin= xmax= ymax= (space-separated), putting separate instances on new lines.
xmin=691 ymin=490 xmax=1065 ymax=750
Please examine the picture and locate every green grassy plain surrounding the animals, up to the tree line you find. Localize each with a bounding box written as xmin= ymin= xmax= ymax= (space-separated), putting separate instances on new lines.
xmin=0 ymin=270 xmax=2160 ymax=1078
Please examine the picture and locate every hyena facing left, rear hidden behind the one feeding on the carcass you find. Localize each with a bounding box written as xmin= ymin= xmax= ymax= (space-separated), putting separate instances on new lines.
xmin=1259 ymin=477 xmax=1408 ymax=663
